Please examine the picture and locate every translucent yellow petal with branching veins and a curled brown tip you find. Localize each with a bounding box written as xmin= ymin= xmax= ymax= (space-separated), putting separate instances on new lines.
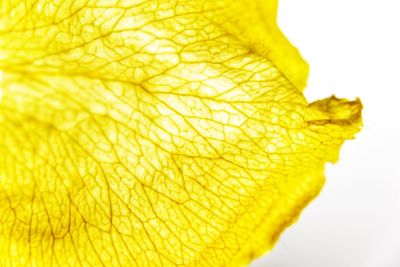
xmin=0 ymin=0 xmax=361 ymax=266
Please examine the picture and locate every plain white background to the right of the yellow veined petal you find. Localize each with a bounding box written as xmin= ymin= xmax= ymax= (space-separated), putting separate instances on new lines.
xmin=251 ymin=0 xmax=400 ymax=267
